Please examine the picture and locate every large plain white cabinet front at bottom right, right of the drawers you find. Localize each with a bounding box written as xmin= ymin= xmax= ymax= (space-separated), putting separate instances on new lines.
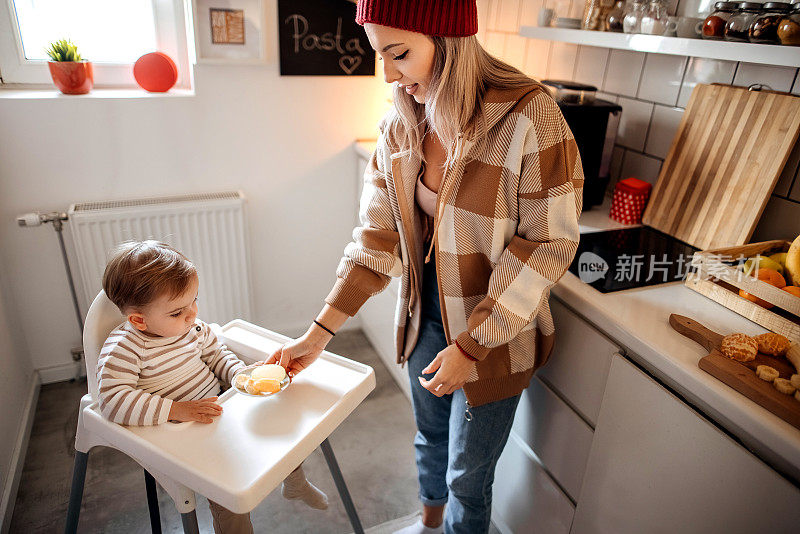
xmin=572 ymin=355 xmax=800 ymax=534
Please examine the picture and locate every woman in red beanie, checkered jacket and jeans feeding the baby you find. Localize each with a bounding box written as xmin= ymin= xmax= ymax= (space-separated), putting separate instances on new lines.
xmin=268 ymin=0 xmax=583 ymax=534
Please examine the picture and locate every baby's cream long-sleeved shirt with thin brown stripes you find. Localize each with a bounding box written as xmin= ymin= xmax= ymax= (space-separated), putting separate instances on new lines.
xmin=97 ymin=320 xmax=245 ymax=425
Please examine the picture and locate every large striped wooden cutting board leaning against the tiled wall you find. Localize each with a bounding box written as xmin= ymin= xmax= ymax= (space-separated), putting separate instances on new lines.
xmin=642 ymin=84 xmax=800 ymax=250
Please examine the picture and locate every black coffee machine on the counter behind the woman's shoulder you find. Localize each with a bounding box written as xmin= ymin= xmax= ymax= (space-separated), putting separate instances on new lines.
xmin=542 ymin=80 xmax=622 ymax=210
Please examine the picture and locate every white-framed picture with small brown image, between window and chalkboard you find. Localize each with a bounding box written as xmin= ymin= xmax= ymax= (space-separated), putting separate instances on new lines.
xmin=192 ymin=0 xmax=266 ymax=65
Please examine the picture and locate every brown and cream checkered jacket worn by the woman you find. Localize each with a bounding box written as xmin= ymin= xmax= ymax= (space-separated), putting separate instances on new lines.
xmin=325 ymin=85 xmax=583 ymax=406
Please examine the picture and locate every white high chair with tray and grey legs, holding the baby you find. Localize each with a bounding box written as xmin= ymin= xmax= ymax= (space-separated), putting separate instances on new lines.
xmin=65 ymin=291 xmax=375 ymax=534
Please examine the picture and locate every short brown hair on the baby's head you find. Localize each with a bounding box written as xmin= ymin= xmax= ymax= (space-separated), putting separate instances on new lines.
xmin=103 ymin=240 xmax=197 ymax=313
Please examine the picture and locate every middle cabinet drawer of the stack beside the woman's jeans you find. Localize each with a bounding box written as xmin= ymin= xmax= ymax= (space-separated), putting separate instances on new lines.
xmin=512 ymin=377 xmax=593 ymax=501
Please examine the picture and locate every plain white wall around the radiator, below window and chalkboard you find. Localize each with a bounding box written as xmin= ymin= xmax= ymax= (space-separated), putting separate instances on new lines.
xmin=0 ymin=1 xmax=387 ymax=381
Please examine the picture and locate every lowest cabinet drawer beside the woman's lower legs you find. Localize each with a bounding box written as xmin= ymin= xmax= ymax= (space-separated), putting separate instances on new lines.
xmin=492 ymin=434 xmax=575 ymax=534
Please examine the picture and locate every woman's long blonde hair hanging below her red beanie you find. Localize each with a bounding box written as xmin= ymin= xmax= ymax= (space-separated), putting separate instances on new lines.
xmin=382 ymin=35 xmax=541 ymax=169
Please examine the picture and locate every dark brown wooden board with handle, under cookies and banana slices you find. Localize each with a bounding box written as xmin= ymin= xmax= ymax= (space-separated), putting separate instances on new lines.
xmin=669 ymin=313 xmax=800 ymax=428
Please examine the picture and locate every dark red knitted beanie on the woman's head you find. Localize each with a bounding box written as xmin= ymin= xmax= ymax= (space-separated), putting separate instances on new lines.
xmin=356 ymin=0 xmax=478 ymax=37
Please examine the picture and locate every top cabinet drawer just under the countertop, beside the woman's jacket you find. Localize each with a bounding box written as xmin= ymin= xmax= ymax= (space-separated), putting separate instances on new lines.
xmin=537 ymin=298 xmax=619 ymax=426
